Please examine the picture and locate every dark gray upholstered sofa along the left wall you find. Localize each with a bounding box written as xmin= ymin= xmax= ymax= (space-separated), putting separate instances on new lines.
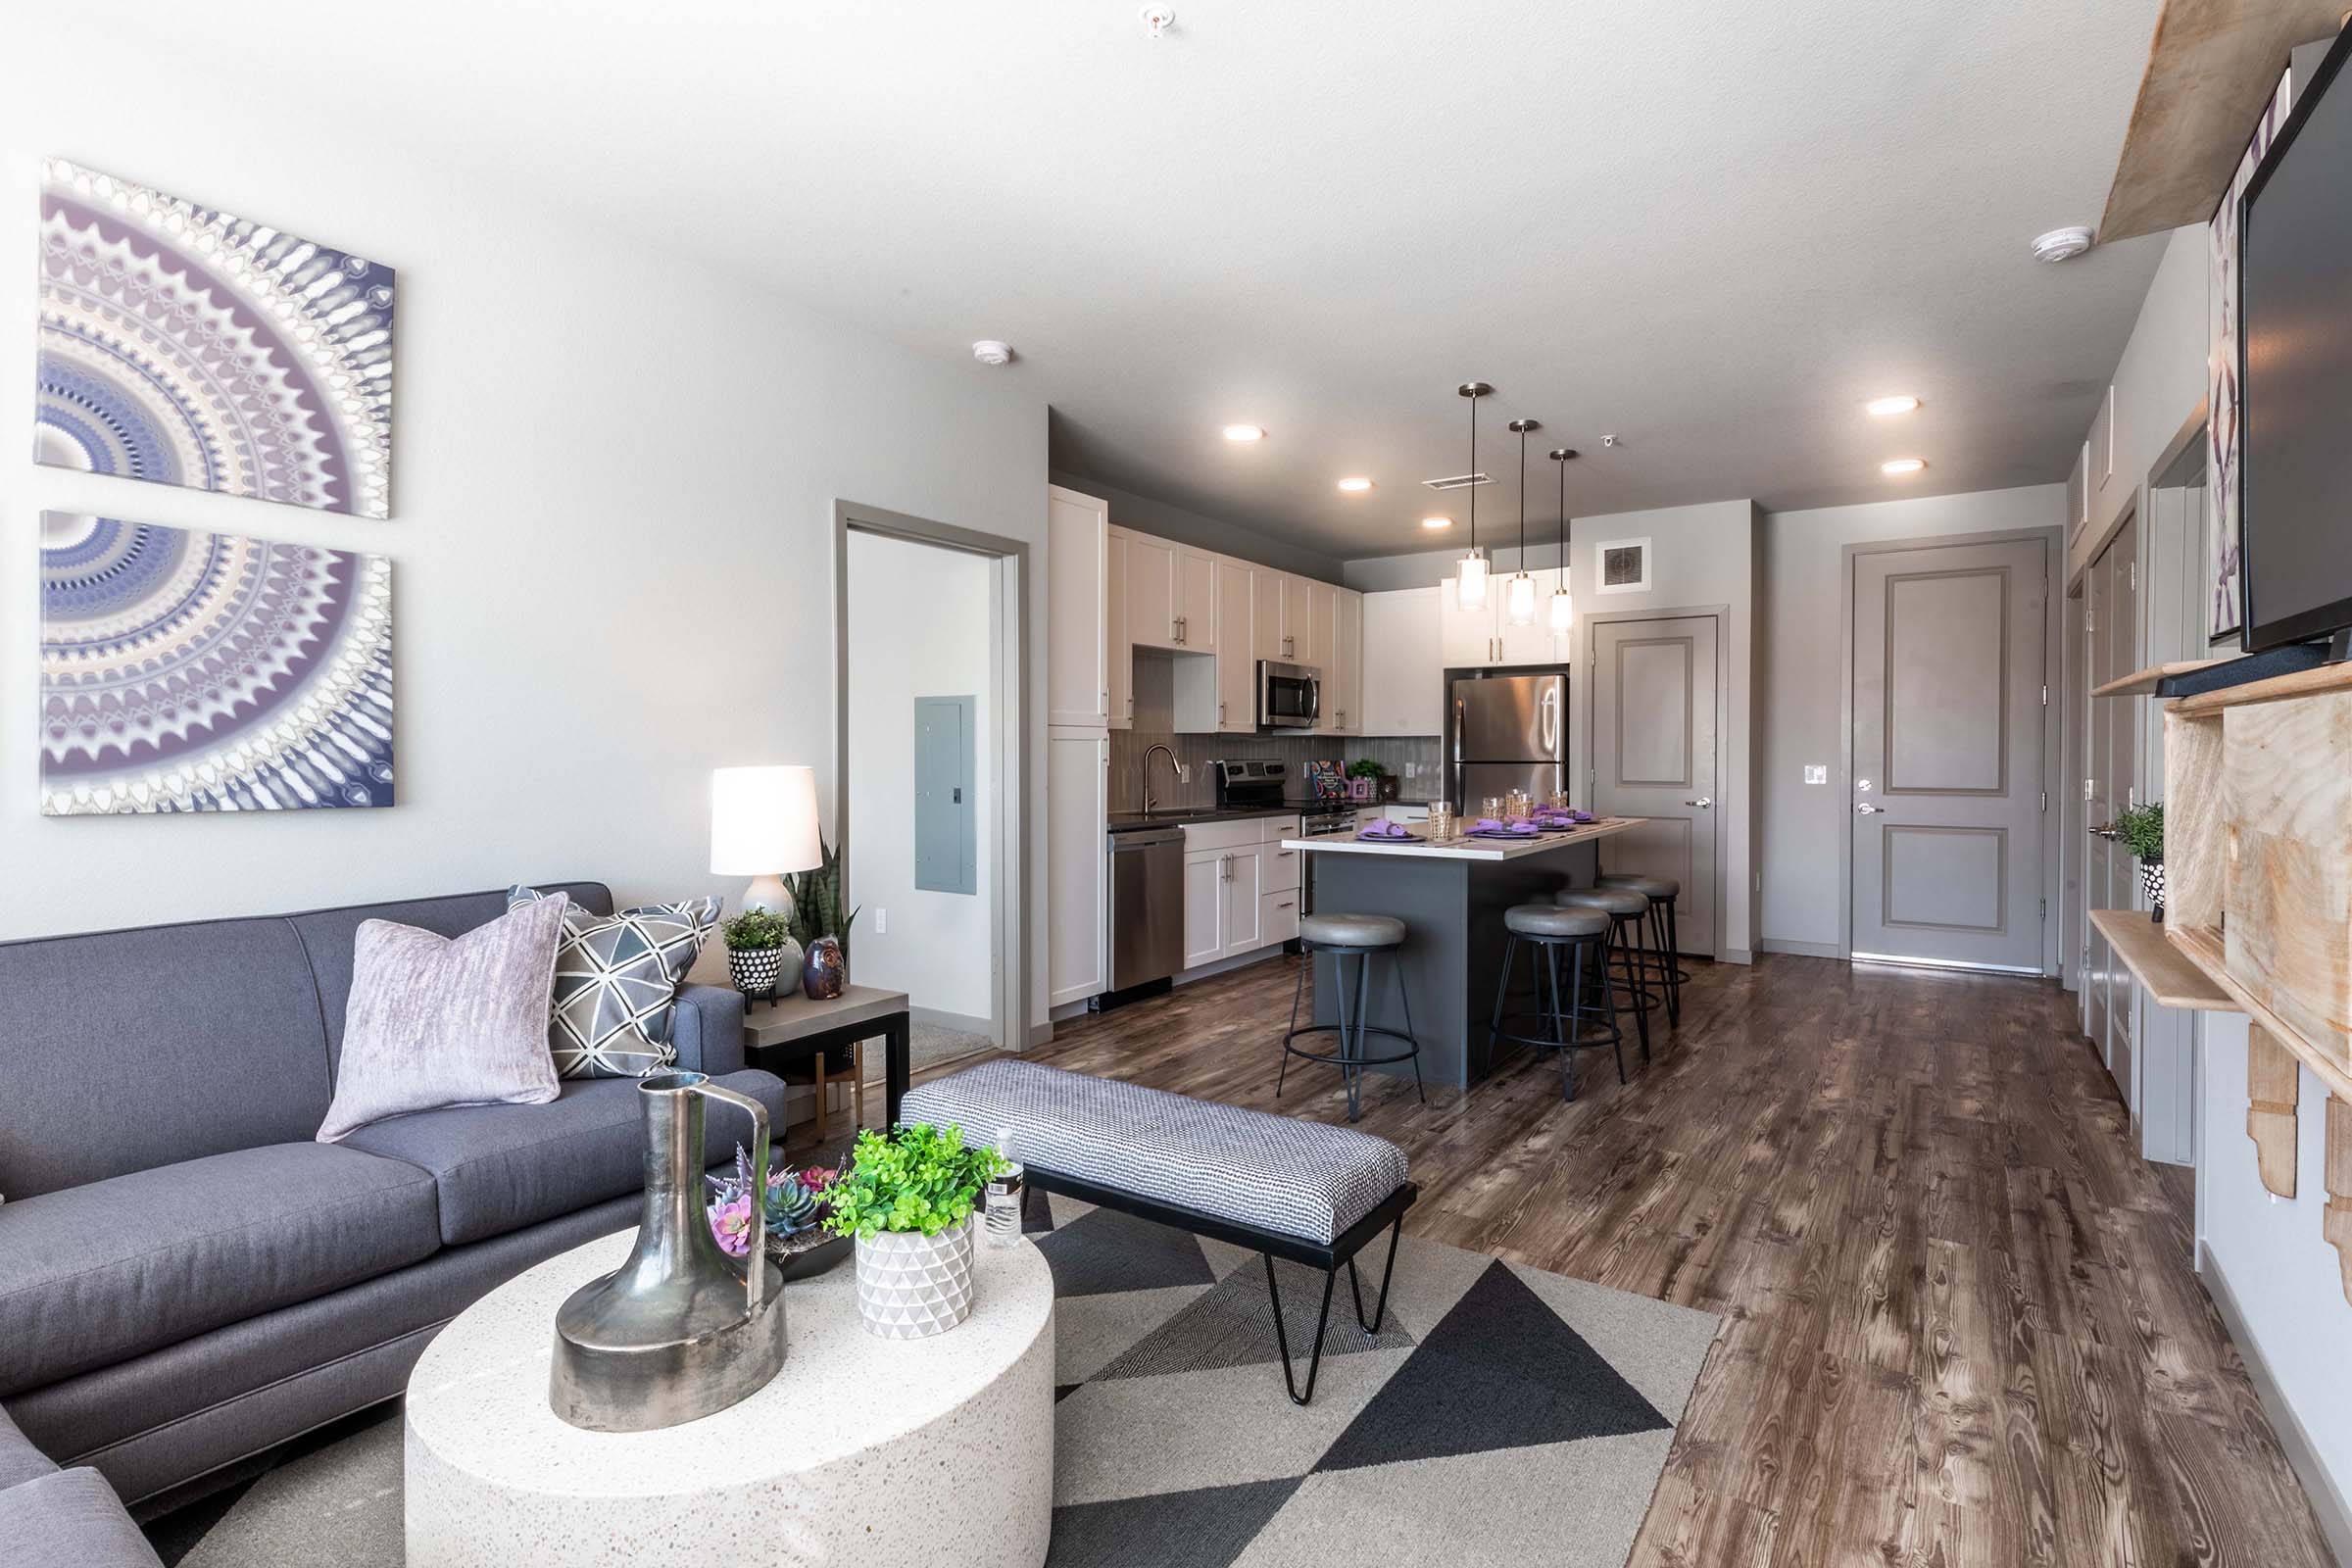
xmin=0 ymin=884 xmax=783 ymax=1533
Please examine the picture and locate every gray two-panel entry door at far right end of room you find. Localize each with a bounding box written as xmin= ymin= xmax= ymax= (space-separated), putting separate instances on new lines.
xmin=1851 ymin=541 xmax=2048 ymax=973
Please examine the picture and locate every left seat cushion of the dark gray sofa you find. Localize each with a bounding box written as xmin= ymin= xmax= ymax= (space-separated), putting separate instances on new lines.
xmin=0 ymin=1143 xmax=440 ymax=1394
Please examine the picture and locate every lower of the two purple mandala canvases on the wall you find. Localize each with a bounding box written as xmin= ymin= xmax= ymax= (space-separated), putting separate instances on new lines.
xmin=40 ymin=513 xmax=393 ymax=815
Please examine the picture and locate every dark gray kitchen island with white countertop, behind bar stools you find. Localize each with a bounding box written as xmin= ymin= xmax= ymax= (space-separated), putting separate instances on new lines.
xmin=1282 ymin=815 xmax=1642 ymax=1089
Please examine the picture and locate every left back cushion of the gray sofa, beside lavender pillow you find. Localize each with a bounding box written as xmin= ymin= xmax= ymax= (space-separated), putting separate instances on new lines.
xmin=0 ymin=919 xmax=331 ymax=1203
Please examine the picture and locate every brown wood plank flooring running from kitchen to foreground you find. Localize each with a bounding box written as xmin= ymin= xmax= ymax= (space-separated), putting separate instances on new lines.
xmin=978 ymin=956 xmax=2328 ymax=1568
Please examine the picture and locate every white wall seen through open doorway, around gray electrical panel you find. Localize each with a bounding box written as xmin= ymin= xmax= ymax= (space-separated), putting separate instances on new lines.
xmin=849 ymin=534 xmax=995 ymax=1018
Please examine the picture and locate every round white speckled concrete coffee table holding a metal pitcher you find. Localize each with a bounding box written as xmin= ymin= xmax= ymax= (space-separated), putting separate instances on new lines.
xmin=405 ymin=1232 xmax=1054 ymax=1568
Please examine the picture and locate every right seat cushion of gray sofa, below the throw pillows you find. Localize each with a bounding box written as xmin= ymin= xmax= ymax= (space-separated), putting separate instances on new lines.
xmin=343 ymin=1069 xmax=783 ymax=1246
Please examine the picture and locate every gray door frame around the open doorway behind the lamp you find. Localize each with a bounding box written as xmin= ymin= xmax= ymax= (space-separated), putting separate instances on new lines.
xmin=833 ymin=501 xmax=1033 ymax=1054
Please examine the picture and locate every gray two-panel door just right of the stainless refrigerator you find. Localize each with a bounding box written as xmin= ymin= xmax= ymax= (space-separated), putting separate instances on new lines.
xmin=1592 ymin=615 xmax=1724 ymax=956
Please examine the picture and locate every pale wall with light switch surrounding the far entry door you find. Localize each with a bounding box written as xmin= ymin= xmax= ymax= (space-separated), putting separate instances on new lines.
xmin=1757 ymin=484 xmax=2065 ymax=953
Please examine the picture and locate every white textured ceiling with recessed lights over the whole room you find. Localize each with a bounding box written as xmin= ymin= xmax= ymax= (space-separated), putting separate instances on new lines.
xmin=69 ymin=0 xmax=2162 ymax=558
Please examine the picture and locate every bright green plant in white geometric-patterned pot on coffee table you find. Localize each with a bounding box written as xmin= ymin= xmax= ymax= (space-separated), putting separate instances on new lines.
xmin=825 ymin=1121 xmax=1004 ymax=1340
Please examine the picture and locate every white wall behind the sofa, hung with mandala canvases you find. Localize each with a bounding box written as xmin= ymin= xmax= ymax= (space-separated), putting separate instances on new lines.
xmin=0 ymin=30 xmax=1047 ymax=973
